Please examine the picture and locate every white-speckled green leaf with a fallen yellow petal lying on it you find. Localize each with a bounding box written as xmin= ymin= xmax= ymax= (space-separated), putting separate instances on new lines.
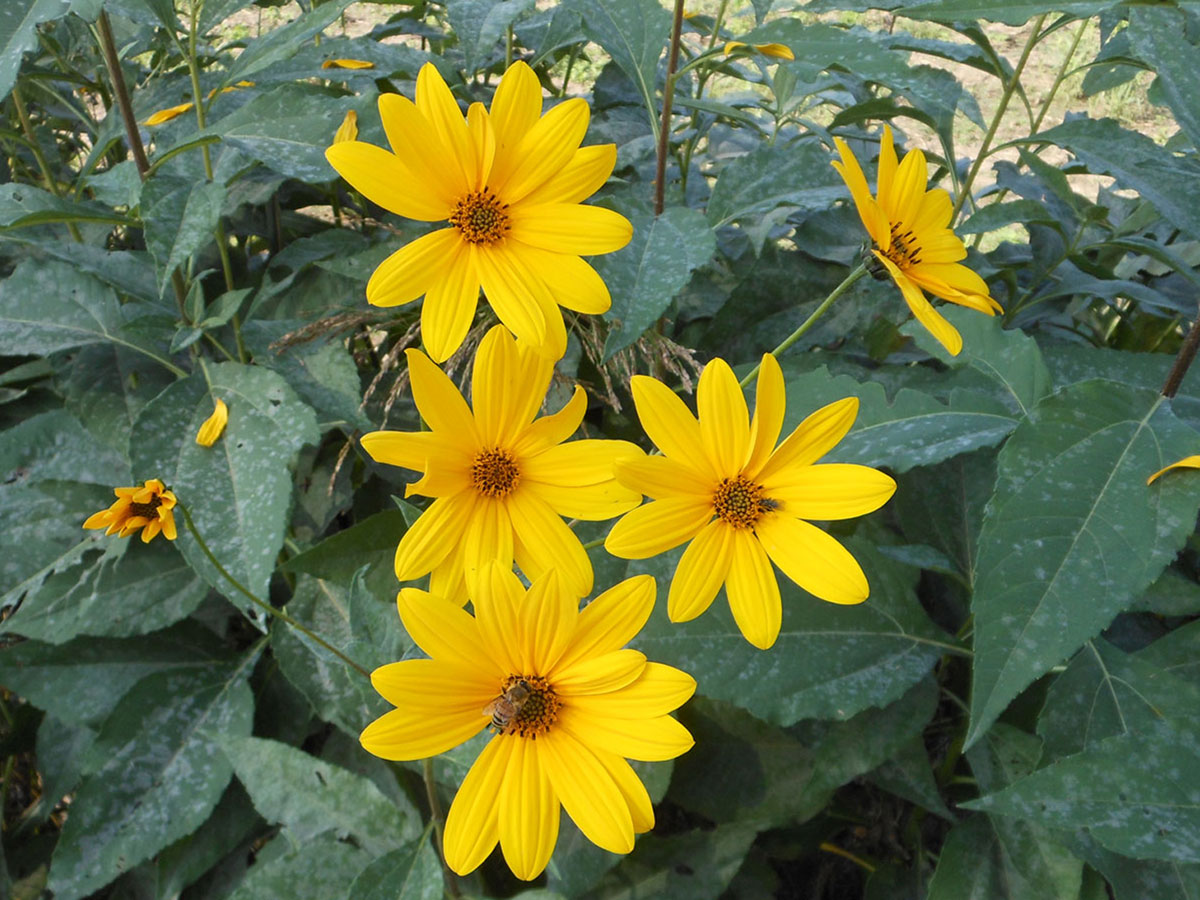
xmin=131 ymin=362 xmax=319 ymax=606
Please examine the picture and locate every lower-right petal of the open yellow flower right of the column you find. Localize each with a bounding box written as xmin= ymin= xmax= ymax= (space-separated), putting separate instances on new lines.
xmin=755 ymin=516 xmax=870 ymax=604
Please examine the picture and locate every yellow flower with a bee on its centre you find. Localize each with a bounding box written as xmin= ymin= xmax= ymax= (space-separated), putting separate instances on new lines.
xmin=360 ymin=566 xmax=696 ymax=881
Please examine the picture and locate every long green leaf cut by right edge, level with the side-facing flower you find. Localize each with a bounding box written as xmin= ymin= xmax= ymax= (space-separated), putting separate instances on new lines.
xmin=1032 ymin=118 xmax=1200 ymax=238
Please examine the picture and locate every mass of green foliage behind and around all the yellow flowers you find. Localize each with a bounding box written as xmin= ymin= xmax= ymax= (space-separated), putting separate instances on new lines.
xmin=0 ymin=0 xmax=1200 ymax=900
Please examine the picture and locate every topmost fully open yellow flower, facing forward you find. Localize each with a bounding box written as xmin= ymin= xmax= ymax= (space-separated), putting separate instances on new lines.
xmin=325 ymin=62 xmax=632 ymax=362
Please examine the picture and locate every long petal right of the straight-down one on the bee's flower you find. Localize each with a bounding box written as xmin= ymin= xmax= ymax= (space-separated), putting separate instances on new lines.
xmin=535 ymin=729 xmax=634 ymax=853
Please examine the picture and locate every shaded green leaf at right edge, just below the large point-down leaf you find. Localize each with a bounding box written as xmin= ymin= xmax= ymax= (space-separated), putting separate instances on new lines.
xmin=1038 ymin=638 xmax=1200 ymax=760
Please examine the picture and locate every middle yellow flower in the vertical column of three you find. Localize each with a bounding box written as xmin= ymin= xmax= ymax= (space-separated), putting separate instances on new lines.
xmin=362 ymin=325 xmax=642 ymax=598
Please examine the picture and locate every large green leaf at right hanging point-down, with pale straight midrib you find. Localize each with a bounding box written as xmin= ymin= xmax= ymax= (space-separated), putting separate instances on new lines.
xmin=967 ymin=379 xmax=1200 ymax=745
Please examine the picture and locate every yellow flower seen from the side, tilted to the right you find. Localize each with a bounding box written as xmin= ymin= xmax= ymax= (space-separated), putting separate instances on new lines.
xmin=833 ymin=125 xmax=1004 ymax=355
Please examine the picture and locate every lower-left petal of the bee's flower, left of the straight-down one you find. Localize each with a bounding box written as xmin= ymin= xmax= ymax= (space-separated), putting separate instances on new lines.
xmin=442 ymin=736 xmax=520 ymax=875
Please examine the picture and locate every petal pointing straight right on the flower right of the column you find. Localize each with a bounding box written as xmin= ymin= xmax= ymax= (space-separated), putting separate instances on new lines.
xmin=763 ymin=463 xmax=896 ymax=521
